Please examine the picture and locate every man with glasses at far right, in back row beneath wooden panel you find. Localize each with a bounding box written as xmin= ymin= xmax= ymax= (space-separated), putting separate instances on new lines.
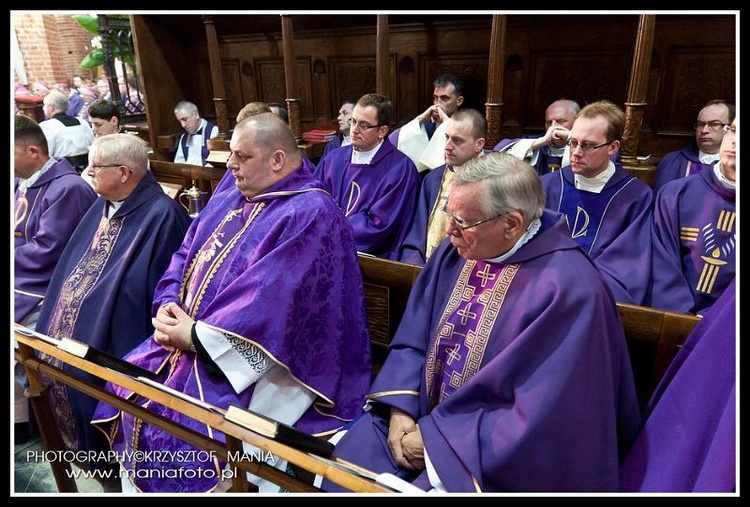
xmin=654 ymin=99 xmax=735 ymax=193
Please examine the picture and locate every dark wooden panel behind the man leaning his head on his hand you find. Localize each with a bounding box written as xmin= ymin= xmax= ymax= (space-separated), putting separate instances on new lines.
xmin=420 ymin=56 xmax=489 ymax=114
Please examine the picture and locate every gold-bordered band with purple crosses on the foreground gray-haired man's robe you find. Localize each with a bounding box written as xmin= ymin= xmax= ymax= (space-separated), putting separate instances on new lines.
xmin=425 ymin=260 xmax=519 ymax=410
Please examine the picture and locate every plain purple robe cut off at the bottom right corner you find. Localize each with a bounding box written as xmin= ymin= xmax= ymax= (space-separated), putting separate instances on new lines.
xmin=620 ymin=280 xmax=738 ymax=493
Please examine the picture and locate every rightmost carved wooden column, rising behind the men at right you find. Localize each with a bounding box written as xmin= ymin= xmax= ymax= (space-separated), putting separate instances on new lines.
xmin=620 ymin=14 xmax=656 ymax=185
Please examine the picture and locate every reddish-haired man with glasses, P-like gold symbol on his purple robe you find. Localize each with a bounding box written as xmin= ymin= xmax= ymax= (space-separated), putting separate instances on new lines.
xmin=541 ymin=100 xmax=654 ymax=305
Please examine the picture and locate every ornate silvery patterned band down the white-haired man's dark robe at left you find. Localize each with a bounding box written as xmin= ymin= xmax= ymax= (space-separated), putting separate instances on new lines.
xmin=40 ymin=217 xmax=123 ymax=450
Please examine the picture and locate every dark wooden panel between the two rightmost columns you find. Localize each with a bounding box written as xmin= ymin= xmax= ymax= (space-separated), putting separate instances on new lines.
xmin=525 ymin=48 xmax=633 ymax=131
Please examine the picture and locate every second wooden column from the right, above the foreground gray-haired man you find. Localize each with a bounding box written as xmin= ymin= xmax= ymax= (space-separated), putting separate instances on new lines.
xmin=484 ymin=14 xmax=506 ymax=149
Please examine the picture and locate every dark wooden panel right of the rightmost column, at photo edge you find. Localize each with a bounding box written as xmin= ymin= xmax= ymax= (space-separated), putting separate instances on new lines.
xmin=654 ymin=46 xmax=736 ymax=135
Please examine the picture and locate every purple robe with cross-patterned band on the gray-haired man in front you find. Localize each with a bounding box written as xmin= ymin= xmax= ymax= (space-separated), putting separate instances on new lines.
xmin=323 ymin=210 xmax=639 ymax=492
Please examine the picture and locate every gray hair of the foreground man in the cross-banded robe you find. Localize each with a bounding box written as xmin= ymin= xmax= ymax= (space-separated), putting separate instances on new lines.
xmin=451 ymin=152 xmax=545 ymax=224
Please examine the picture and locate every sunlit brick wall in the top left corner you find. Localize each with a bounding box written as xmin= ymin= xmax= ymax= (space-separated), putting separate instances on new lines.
xmin=12 ymin=13 xmax=103 ymax=85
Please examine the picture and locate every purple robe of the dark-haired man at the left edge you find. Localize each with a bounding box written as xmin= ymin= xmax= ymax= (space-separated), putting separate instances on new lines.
xmin=13 ymin=159 xmax=96 ymax=322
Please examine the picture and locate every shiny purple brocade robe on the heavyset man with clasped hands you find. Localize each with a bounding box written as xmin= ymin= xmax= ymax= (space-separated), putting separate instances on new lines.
xmin=93 ymin=167 xmax=372 ymax=492
